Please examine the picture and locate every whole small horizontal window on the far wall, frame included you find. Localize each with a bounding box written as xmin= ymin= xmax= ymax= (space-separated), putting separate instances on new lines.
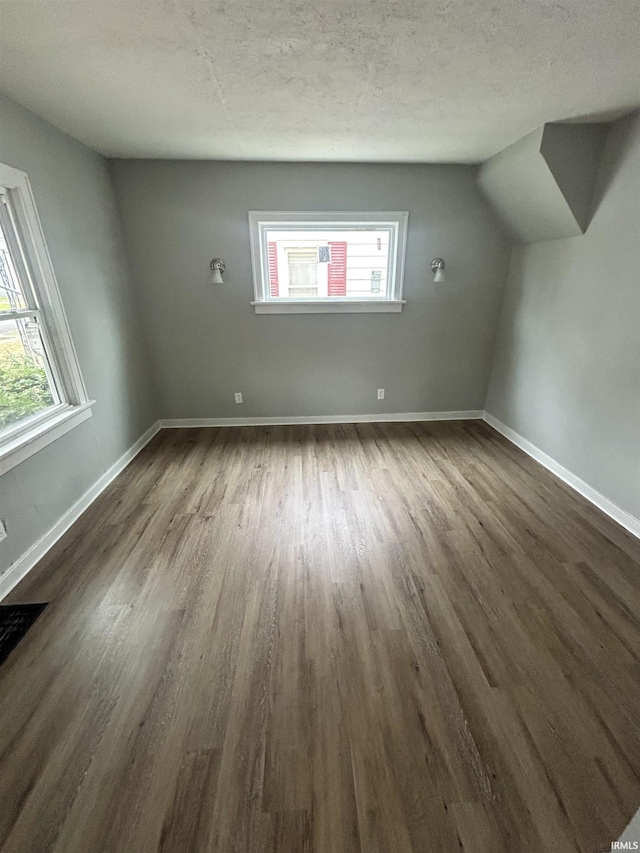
xmin=249 ymin=211 xmax=409 ymax=314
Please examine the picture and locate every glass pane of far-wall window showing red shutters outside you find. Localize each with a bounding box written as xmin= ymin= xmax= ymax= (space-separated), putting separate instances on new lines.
xmin=265 ymin=227 xmax=392 ymax=300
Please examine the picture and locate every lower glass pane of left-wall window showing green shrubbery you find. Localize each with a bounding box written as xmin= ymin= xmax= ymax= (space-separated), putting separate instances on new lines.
xmin=0 ymin=318 xmax=58 ymax=429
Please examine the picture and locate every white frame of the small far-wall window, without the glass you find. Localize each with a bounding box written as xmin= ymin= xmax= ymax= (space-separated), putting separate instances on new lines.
xmin=249 ymin=210 xmax=409 ymax=314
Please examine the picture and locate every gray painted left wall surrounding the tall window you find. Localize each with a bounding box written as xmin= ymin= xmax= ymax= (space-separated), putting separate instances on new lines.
xmin=0 ymin=96 xmax=157 ymax=575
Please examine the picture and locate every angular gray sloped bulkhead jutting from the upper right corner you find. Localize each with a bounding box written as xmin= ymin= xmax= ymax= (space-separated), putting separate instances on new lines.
xmin=478 ymin=124 xmax=606 ymax=243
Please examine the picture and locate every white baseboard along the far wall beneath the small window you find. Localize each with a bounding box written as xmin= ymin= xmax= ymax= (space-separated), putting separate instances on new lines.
xmin=159 ymin=409 xmax=484 ymax=429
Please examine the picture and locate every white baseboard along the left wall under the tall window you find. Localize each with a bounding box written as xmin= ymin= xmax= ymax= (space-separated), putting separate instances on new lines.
xmin=0 ymin=421 xmax=160 ymax=601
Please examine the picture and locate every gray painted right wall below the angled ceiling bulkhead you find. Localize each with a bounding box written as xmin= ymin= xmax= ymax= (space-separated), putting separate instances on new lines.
xmin=486 ymin=113 xmax=640 ymax=518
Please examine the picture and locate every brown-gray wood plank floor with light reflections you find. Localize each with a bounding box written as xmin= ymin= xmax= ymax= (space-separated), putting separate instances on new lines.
xmin=0 ymin=422 xmax=640 ymax=853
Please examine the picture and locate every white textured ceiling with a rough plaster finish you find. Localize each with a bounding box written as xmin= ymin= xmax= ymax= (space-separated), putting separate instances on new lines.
xmin=0 ymin=0 xmax=640 ymax=162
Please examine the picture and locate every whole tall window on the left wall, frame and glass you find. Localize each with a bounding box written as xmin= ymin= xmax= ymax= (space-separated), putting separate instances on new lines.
xmin=0 ymin=164 xmax=91 ymax=474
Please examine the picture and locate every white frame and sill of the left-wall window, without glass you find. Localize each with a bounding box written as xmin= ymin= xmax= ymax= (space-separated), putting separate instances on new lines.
xmin=0 ymin=163 xmax=95 ymax=475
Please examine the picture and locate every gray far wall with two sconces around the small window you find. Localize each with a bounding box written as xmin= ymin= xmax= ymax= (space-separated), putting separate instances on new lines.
xmin=111 ymin=160 xmax=510 ymax=418
